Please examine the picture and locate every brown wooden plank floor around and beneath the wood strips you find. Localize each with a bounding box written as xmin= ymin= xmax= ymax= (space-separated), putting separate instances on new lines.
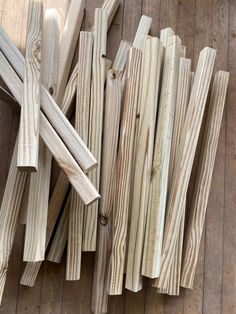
xmin=0 ymin=0 xmax=236 ymax=314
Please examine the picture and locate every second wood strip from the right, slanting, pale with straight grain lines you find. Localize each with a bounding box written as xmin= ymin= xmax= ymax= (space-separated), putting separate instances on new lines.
xmin=158 ymin=47 xmax=216 ymax=289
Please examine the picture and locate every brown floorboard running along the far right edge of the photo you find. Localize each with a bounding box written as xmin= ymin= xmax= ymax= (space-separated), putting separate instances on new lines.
xmin=222 ymin=0 xmax=236 ymax=314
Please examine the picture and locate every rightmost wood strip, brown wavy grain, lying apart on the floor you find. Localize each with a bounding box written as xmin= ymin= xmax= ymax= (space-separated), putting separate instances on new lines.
xmin=181 ymin=71 xmax=229 ymax=289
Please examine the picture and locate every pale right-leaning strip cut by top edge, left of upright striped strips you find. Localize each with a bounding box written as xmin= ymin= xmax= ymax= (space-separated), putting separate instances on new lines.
xmin=56 ymin=0 xmax=85 ymax=105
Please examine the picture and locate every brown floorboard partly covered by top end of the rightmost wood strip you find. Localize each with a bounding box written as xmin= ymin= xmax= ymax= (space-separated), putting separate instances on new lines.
xmin=203 ymin=0 xmax=228 ymax=314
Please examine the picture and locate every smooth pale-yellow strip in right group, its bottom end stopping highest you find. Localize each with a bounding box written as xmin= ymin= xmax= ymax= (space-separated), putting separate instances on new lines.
xmin=141 ymin=35 xmax=181 ymax=278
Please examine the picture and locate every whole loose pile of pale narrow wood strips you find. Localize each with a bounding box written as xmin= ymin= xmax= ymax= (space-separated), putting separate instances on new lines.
xmin=0 ymin=0 xmax=229 ymax=313
